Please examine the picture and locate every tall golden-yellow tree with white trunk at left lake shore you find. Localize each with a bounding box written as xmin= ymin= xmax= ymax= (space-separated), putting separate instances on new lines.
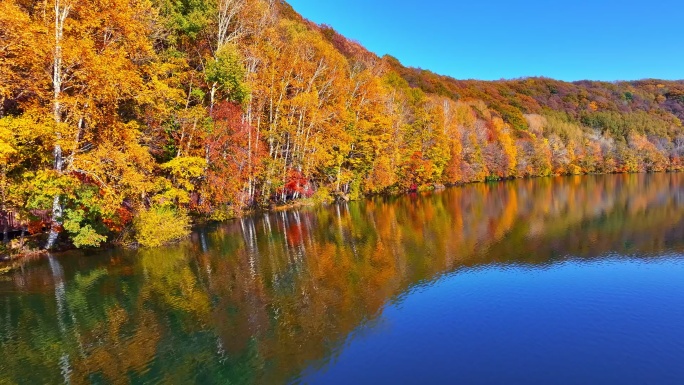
xmin=3 ymin=0 xmax=164 ymax=248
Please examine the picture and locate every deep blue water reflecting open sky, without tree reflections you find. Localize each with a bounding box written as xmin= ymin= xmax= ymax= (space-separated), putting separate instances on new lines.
xmin=300 ymin=254 xmax=684 ymax=384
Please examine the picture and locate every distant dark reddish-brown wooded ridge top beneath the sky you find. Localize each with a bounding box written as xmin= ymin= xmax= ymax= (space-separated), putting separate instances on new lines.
xmin=386 ymin=57 xmax=684 ymax=136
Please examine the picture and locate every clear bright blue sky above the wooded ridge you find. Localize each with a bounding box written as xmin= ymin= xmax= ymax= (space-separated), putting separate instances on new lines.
xmin=288 ymin=0 xmax=684 ymax=81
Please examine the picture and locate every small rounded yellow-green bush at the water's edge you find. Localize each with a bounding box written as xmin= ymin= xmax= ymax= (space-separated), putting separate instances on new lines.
xmin=133 ymin=207 xmax=190 ymax=247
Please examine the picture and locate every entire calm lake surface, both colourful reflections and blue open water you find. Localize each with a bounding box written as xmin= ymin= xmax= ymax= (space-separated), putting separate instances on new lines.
xmin=0 ymin=174 xmax=684 ymax=384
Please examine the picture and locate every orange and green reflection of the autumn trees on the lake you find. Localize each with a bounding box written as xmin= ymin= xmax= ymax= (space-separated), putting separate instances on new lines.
xmin=0 ymin=174 xmax=684 ymax=384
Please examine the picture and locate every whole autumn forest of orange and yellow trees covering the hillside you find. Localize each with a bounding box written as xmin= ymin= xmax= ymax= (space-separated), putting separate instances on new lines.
xmin=0 ymin=0 xmax=684 ymax=249
